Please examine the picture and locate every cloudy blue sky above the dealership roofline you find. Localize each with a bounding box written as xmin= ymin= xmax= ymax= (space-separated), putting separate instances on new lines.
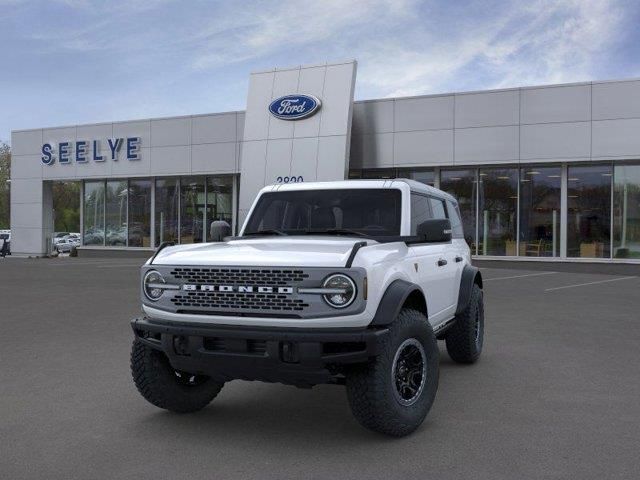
xmin=0 ymin=0 xmax=640 ymax=142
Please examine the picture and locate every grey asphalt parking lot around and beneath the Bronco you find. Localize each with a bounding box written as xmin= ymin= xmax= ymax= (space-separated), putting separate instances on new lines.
xmin=0 ymin=258 xmax=640 ymax=480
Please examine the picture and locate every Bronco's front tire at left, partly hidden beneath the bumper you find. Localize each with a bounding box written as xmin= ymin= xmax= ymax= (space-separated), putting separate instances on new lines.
xmin=131 ymin=340 xmax=224 ymax=413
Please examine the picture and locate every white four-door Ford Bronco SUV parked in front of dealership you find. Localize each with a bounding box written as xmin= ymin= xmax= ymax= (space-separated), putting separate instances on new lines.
xmin=131 ymin=180 xmax=484 ymax=436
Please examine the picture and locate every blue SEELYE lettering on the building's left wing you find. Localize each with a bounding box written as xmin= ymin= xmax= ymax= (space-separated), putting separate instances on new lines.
xmin=41 ymin=137 xmax=140 ymax=165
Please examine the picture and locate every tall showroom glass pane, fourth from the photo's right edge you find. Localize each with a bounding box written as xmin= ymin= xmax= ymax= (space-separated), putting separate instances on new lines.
xmin=478 ymin=168 xmax=518 ymax=256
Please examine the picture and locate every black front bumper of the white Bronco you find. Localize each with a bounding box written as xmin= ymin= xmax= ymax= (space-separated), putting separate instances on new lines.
xmin=131 ymin=318 xmax=389 ymax=386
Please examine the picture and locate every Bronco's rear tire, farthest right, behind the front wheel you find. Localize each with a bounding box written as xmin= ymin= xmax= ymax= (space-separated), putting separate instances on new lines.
xmin=444 ymin=283 xmax=484 ymax=363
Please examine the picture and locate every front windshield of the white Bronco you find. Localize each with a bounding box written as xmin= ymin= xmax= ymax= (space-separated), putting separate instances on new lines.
xmin=244 ymin=189 xmax=401 ymax=237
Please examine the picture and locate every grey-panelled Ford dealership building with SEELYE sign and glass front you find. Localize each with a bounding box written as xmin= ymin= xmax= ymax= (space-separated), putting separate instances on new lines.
xmin=11 ymin=61 xmax=640 ymax=263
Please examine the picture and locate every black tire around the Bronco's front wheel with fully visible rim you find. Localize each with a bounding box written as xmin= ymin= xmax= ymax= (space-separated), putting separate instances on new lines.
xmin=346 ymin=308 xmax=439 ymax=437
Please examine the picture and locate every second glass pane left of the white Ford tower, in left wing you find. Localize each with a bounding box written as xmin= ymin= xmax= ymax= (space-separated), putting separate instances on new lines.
xmin=180 ymin=177 xmax=206 ymax=243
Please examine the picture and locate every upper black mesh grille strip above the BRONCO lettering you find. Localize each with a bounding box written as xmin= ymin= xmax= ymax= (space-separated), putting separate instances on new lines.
xmin=171 ymin=267 xmax=309 ymax=286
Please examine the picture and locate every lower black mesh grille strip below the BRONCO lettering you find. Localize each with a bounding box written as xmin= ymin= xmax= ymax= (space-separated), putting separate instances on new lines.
xmin=171 ymin=291 xmax=309 ymax=312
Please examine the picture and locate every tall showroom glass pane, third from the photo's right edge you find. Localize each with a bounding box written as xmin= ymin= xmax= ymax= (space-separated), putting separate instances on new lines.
xmin=519 ymin=166 xmax=561 ymax=257
